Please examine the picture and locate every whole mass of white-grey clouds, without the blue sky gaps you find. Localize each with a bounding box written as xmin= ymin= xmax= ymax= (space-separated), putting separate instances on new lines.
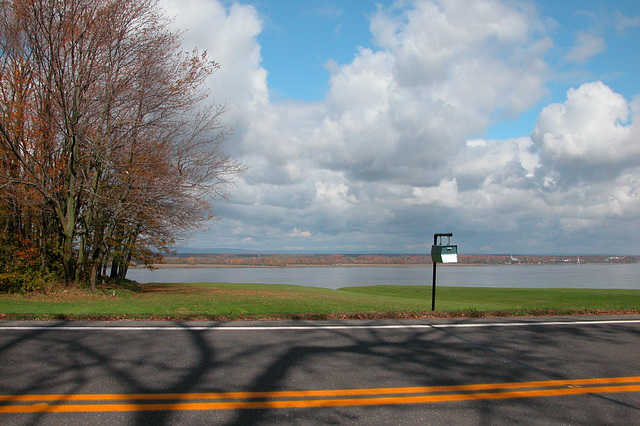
xmin=165 ymin=0 xmax=640 ymax=252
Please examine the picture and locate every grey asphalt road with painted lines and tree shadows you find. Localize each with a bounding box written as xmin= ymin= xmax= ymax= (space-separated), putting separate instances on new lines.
xmin=0 ymin=316 xmax=640 ymax=425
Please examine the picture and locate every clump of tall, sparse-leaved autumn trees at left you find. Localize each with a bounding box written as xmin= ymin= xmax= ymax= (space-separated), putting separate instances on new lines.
xmin=0 ymin=0 xmax=244 ymax=289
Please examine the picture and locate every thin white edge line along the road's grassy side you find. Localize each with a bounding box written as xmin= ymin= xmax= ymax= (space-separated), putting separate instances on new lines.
xmin=0 ymin=319 xmax=640 ymax=331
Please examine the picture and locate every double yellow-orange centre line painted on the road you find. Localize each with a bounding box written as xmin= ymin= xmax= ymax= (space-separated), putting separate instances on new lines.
xmin=0 ymin=376 xmax=640 ymax=414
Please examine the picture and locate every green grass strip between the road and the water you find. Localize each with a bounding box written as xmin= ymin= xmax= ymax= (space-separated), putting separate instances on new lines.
xmin=0 ymin=283 xmax=640 ymax=320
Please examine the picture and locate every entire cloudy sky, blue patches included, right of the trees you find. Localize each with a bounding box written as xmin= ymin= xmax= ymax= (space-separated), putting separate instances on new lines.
xmin=161 ymin=0 xmax=640 ymax=254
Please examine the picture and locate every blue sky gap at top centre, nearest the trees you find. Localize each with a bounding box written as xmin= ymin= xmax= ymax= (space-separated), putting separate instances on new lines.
xmin=253 ymin=1 xmax=382 ymax=101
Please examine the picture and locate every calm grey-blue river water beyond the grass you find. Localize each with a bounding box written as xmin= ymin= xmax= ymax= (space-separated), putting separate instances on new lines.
xmin=127 ymin=263 xmax=640 ymax=289
